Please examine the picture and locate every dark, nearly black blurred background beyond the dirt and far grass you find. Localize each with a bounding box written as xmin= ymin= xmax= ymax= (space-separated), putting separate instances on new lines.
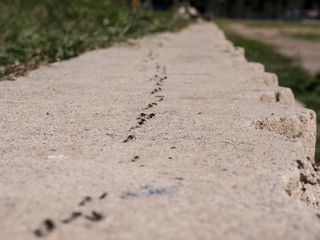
xmin=154 ymin=0 xmax=320 ymax=20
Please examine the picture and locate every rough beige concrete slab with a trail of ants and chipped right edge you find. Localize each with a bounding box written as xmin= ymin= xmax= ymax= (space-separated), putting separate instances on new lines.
xmin=0 ymin=23 xmax=320 ymax=240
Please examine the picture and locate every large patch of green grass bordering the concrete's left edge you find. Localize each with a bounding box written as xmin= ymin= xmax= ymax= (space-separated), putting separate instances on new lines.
xmin=0 ymin=0 xmax=189 ymax=80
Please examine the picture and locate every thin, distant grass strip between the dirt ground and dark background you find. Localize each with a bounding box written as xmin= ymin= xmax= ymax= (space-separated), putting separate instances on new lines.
xmin=242 ymin=21 xmax=320 ymax=29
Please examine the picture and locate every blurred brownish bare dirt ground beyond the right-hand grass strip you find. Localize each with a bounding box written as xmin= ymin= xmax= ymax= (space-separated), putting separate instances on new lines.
xmin=231 ymin=23 xmax=320 ymax=74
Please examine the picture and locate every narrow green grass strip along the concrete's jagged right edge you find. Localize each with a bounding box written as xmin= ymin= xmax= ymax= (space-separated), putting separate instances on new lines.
xmin=216 ymin=19 xmax=320 ymax=163
